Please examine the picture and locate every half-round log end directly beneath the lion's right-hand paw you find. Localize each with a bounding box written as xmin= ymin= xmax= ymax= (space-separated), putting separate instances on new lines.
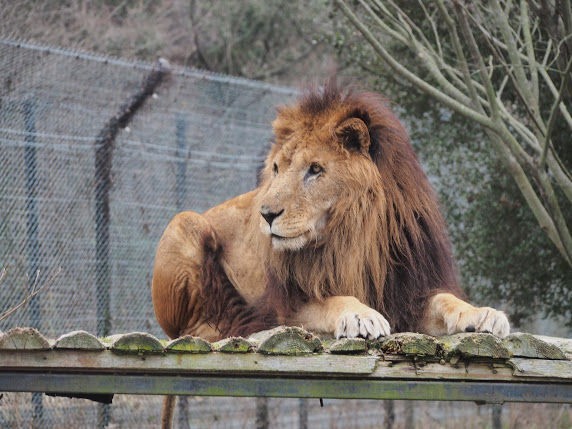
xmin=439 ymin=333 xmax=510 ymax=359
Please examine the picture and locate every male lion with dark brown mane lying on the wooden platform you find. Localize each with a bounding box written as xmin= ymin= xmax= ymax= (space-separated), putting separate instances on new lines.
xmin=152 ymin=80 xmax=509 ymax=340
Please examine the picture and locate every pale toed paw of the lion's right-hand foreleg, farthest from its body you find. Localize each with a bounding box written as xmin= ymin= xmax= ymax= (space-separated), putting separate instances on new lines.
xmin=445 ymin=307 xmax=510 ymax=337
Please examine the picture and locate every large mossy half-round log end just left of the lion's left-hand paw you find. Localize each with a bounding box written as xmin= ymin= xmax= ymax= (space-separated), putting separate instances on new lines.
xmin=249 ymin=326 xmax=322 ymax=355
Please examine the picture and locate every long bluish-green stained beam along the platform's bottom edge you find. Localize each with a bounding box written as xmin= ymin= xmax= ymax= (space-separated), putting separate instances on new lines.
xmin=0 ymin=372 xmax=572 ymax=403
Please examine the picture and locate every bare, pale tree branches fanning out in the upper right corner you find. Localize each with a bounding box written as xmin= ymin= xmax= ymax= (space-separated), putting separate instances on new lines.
xmin=334 ymin=0 xmax=572 ymax=266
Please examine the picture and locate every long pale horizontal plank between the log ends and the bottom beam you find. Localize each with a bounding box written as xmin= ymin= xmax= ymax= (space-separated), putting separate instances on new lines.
xmin=4 ymin=350 xmax=572 ymax=384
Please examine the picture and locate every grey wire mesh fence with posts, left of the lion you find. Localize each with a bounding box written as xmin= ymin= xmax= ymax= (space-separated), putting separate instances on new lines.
xmin=0 ymin=40 xmax=302 ymax=427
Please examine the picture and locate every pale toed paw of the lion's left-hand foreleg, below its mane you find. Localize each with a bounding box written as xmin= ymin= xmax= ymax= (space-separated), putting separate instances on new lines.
xmin=335 ymin=307 xmax=390 ymax=340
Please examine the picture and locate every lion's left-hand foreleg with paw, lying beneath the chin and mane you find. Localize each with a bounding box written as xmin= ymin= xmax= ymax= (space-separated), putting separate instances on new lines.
xmin=285 ymin=296 xmax=390 ymax=339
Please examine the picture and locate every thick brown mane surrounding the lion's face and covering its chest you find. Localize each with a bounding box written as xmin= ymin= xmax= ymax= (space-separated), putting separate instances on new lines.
xmin=266 ymin=80 xmax=462 ymax=331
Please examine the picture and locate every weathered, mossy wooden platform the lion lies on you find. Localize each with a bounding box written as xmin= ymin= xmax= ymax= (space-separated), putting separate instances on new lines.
xmin=0 ymin=327 xmax=572 ymax=403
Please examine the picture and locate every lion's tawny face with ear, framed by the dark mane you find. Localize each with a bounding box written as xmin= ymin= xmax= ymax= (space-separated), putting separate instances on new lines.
xmin=258 ymin=112 xmax=377 ymax=251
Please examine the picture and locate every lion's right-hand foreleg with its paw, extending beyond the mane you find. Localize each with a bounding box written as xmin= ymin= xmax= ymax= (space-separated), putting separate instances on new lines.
xmin=420 ymin=293 xmax=510 ymax=337
